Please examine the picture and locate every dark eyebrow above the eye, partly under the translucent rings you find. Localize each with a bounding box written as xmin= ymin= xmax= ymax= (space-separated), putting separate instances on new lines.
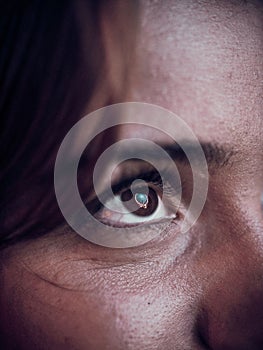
xmin=114 ymin=142 xmax=234 ymax=168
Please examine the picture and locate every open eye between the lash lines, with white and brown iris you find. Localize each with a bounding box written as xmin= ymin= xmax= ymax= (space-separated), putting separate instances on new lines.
xmin=88 ymin=171 xmax=178 ymax=228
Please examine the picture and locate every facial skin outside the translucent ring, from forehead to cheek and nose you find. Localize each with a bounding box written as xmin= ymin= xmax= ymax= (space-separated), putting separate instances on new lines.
xmin=0 ymin=0 xmax=263 ymax=350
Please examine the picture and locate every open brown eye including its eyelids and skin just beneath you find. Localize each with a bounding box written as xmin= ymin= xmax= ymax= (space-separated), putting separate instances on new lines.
xmin=80 ymin=165 xmax=184 ymax=248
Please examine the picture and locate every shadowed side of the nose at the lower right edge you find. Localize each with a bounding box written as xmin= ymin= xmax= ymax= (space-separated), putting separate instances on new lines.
xmin=200 ymin=222 xmax=263 ymax=350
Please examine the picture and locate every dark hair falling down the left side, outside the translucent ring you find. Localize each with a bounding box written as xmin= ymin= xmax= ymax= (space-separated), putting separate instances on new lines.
xmin=0 ymin=0 xmax=138 ymax=243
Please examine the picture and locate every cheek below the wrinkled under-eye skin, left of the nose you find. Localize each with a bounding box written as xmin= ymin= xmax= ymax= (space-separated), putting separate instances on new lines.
xmin=0 ymin=252 xmax=200 ymax=350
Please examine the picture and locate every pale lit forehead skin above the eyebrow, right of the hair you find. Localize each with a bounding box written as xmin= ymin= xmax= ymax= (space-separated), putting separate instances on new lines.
xmin=133 ymin=0 xmax=263 ymax=148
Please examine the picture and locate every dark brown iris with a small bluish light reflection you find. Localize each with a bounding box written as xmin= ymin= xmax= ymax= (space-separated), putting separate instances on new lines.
xmin=120 ymin=187 xmax=159 ymax=216
